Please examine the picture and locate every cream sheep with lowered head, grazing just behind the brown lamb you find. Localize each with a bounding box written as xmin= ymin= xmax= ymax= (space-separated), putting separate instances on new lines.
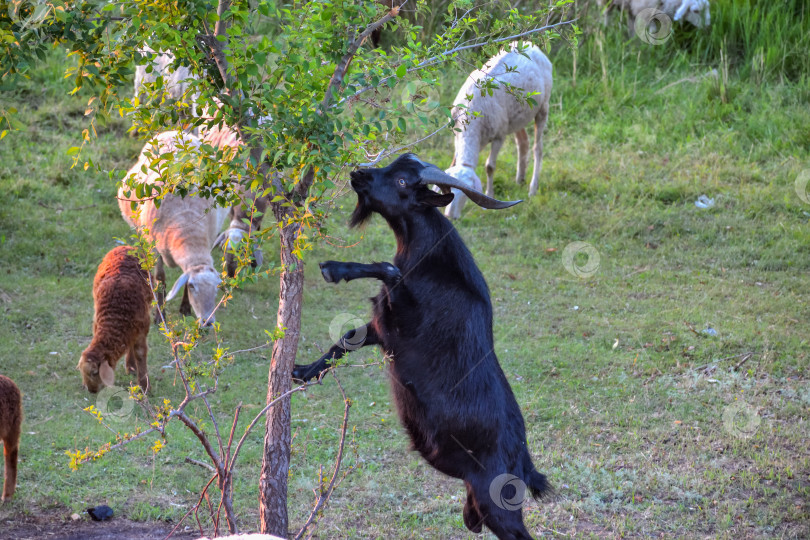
xmin=118 ymin=131 xmax=229 ymax=326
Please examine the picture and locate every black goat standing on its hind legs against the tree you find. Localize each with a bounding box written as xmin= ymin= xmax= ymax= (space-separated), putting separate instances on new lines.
xmin=293 ymin=154 xmax=550 ymax=539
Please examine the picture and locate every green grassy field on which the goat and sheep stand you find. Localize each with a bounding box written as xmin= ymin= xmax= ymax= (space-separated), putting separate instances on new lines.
xmin=0 ymin=2 xmax=810 ymax=539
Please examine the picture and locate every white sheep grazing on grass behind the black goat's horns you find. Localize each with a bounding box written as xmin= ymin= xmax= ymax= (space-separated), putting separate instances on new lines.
xmin=445 ymin=42 xmax=552 ymax=219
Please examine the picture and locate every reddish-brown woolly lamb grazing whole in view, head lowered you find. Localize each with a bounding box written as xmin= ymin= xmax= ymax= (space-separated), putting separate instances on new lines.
xmin=77 ymin=246 xmax=152 ymax=393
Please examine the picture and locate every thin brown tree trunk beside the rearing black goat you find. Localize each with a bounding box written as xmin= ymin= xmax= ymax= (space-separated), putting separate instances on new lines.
xmin=259 ymin=212 xmax=304 ymax=538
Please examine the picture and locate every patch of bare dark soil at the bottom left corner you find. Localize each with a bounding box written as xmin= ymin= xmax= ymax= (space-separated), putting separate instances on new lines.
xmin=0 ymin=516 xmax=200 ymax=540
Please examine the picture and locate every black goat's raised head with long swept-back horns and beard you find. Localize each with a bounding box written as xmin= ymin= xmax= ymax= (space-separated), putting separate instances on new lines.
xmin=351 ymin=154 xmax=521 ymax=226
